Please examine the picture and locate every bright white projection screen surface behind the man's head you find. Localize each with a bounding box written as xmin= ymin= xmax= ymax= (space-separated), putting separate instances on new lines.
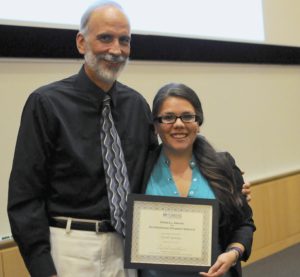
xmin=0 ymin=0 xmax=264 ymax=43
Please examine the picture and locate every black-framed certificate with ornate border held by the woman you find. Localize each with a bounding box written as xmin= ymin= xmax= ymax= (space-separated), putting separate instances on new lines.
xmin=125 ymin=194 xmax=218 ymax=271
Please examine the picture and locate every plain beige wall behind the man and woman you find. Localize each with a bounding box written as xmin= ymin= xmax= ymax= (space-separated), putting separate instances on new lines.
xmin=0 ymin=0 xmax=300 ymax=236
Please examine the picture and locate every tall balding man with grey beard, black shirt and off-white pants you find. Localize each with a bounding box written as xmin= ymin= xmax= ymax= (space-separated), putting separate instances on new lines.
xmin=8 ymin=1 xmax=251 ymax=277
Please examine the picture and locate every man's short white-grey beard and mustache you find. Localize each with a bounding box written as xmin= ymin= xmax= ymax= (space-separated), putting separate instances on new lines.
xmin=84 ymin=50 xmax=128 ymax=83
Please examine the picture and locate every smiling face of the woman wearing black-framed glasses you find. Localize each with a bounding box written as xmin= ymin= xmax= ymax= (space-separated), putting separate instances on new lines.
xmin=155 ymin=96 xmax=200 ymax=155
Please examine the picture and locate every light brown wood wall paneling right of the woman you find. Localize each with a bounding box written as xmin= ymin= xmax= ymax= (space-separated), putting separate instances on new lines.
xmin=246 ymin=171 xmax=300 ymax=265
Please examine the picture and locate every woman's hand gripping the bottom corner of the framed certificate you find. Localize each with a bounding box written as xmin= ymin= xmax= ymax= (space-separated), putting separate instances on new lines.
xmin=199 ymin=251 xmax=237 ymax=277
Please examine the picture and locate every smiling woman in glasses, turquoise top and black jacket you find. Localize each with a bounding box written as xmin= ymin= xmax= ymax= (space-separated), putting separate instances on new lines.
xmin=141 ymin=83 xmax=255 ymax=277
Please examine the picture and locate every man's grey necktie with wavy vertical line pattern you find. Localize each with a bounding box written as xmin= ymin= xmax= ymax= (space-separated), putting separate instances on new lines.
xmin=100 ymin=94 xmax=129 ymax=236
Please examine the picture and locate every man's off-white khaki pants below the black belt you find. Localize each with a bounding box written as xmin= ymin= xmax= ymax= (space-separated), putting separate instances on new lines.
xmin=50 ymin=227 xmax=137 ymax=277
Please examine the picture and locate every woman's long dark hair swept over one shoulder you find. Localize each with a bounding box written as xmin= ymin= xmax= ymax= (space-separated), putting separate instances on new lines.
xmin=152 ymin=83 xmax=242 ymax=225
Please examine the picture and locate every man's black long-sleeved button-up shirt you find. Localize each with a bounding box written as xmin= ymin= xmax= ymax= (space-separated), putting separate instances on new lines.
xmin=8 ymin=68 xmax=157 ymax=277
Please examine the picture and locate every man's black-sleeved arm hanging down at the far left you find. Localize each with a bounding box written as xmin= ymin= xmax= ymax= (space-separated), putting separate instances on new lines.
xmin=8 ymin=93 xmax=56 ymax=277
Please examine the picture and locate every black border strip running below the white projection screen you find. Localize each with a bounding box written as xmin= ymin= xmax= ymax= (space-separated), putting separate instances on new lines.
xmin=0 ymin=25 xmax=300 ymax=65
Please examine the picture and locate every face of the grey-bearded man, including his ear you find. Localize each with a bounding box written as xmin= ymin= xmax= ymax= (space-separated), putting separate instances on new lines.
xmin=77 ymin=6 xmax=130 ymax=88
